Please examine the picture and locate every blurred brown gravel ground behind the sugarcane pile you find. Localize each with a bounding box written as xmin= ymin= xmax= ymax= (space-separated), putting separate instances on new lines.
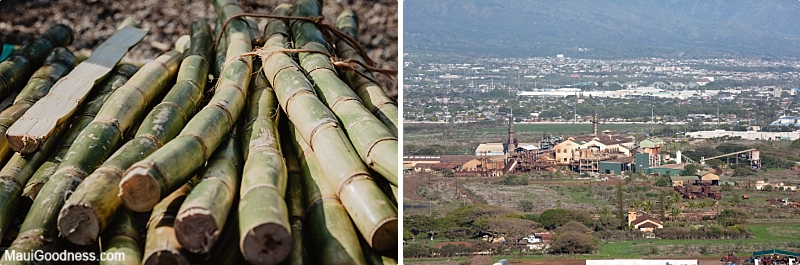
xmin=0 ymin=0 xmax=398 ymax=98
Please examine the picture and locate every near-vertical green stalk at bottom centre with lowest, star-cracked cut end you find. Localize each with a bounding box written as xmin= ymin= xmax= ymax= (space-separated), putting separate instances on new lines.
xmin=239 ymin=59 xmax=292 ymax=264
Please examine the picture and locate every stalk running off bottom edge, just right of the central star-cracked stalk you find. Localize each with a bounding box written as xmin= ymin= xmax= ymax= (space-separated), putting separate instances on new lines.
xmin=290 ymin=124 xmax=367 ymax=265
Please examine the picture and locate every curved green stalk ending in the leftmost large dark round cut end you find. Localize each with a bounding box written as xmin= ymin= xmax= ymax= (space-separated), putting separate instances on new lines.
xmin=58 ymin=20 xmax=212 ymax=245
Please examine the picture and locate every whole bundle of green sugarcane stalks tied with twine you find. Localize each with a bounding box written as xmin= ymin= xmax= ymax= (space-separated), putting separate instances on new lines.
xmin=0 ymin=0 xmax=398 ymax=264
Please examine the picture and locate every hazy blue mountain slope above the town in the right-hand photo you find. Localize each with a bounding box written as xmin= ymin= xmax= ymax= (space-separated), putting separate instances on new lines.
xmin=404 ymin=0 xmax=800 ymax=57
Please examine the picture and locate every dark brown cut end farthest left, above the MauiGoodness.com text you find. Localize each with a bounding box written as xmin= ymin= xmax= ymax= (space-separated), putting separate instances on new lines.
xmin=58 ymin=203 xmax=100 ymax=246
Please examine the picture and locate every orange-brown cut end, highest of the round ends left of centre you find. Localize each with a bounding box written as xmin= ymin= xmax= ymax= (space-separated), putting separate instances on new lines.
xmin=119 ymin=167 xmax=161 ymax=213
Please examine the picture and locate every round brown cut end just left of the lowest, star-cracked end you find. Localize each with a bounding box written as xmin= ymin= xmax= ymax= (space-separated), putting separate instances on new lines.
xmin=174 ymin=208 xmax=220 ymax=253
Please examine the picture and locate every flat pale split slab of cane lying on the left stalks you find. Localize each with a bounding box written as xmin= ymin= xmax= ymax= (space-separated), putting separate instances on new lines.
xmin=6 ymin=27 xmax=147 ymax=154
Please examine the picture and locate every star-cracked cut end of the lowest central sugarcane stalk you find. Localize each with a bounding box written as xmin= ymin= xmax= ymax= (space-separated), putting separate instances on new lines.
xmin=244 ymin=223 xmax=294 ymax=265
